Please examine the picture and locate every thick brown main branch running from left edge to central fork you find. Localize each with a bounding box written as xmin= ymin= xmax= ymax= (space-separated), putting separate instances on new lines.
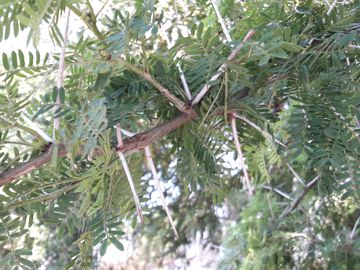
xmin=0 ymin=109 xmax=196 ymax=187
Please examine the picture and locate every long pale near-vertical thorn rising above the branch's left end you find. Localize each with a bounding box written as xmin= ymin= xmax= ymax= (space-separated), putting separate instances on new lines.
xmin=53 ymin=9 xmax=70 ymax=141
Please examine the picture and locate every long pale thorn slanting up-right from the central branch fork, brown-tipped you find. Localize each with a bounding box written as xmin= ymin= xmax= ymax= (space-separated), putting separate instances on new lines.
xmin=191 ymin=30 xmax=255 ymax=105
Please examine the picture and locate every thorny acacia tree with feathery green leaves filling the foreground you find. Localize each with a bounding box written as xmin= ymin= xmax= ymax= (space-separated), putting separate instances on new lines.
xmin=0 ymin=0 xmax=360 ymax=269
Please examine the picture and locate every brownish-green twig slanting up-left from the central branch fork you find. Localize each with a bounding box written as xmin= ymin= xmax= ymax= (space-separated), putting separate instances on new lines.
xmin=117 ymin=57 xmax=189 ymax=113
